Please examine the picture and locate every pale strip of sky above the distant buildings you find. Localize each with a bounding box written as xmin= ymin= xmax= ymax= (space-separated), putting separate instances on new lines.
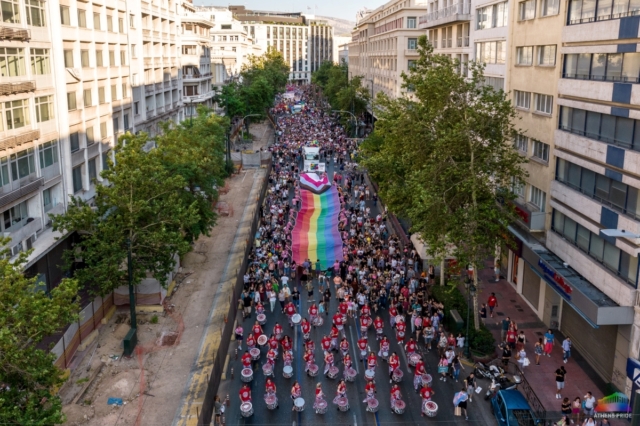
xmin=193 ymin=0 xmax=372 ymax=22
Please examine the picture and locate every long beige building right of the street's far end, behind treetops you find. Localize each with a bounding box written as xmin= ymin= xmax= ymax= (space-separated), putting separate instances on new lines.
xmin=349 ymin=0 xmax=427 ymax=97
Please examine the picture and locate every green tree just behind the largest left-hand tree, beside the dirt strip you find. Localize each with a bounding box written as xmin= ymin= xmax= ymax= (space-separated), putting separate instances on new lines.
xmin=156 ymin=107 xmax=229 ymax=242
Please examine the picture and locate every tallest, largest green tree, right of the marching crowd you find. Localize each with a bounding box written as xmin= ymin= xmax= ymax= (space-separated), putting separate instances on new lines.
xmin=363 ymin=36 xmax=526 ymax=330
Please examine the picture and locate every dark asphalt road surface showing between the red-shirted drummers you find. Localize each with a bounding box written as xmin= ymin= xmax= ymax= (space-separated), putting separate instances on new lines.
xmin=219 ymin=147 xmax=496 ymax=426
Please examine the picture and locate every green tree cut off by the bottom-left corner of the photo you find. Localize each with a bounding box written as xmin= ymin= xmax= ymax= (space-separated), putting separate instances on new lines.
xmin=0 ymin=248 xmax=79 ymax=425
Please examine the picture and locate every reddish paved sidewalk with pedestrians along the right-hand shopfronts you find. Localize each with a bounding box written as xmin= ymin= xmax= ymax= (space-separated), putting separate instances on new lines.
xmin=478 ymin=261 xmax=606 ymax=421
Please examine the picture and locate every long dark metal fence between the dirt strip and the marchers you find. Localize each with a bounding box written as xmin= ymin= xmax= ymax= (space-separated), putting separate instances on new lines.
xmin=198 ymin=161 xmax=272 ymax=426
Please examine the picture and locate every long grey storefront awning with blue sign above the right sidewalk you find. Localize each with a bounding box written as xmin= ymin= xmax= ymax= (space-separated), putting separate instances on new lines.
xmin=509 ymin=226 xmax=634 ymax=328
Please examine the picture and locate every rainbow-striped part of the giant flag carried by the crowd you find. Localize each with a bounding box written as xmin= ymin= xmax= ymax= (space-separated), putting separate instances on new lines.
xmin=291 ymin=187 xmax=342 ymax=269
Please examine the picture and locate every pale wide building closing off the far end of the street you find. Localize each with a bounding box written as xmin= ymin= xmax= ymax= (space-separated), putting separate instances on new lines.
xmin=229 ymin=6 xmax=337 ymax=83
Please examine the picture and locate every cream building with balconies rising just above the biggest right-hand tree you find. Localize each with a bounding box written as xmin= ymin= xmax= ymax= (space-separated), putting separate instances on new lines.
xmin=418 ymin=0 xmax=472 ymax=74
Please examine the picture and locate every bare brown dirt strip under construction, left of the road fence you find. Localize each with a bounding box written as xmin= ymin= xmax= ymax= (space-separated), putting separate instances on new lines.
xmin=60 ymin=124 xmax=272 ymax=426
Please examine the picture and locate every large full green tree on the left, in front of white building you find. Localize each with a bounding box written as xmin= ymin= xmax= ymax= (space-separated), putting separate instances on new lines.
xmin=53 ymin=133 xmax=199 ymax=295
